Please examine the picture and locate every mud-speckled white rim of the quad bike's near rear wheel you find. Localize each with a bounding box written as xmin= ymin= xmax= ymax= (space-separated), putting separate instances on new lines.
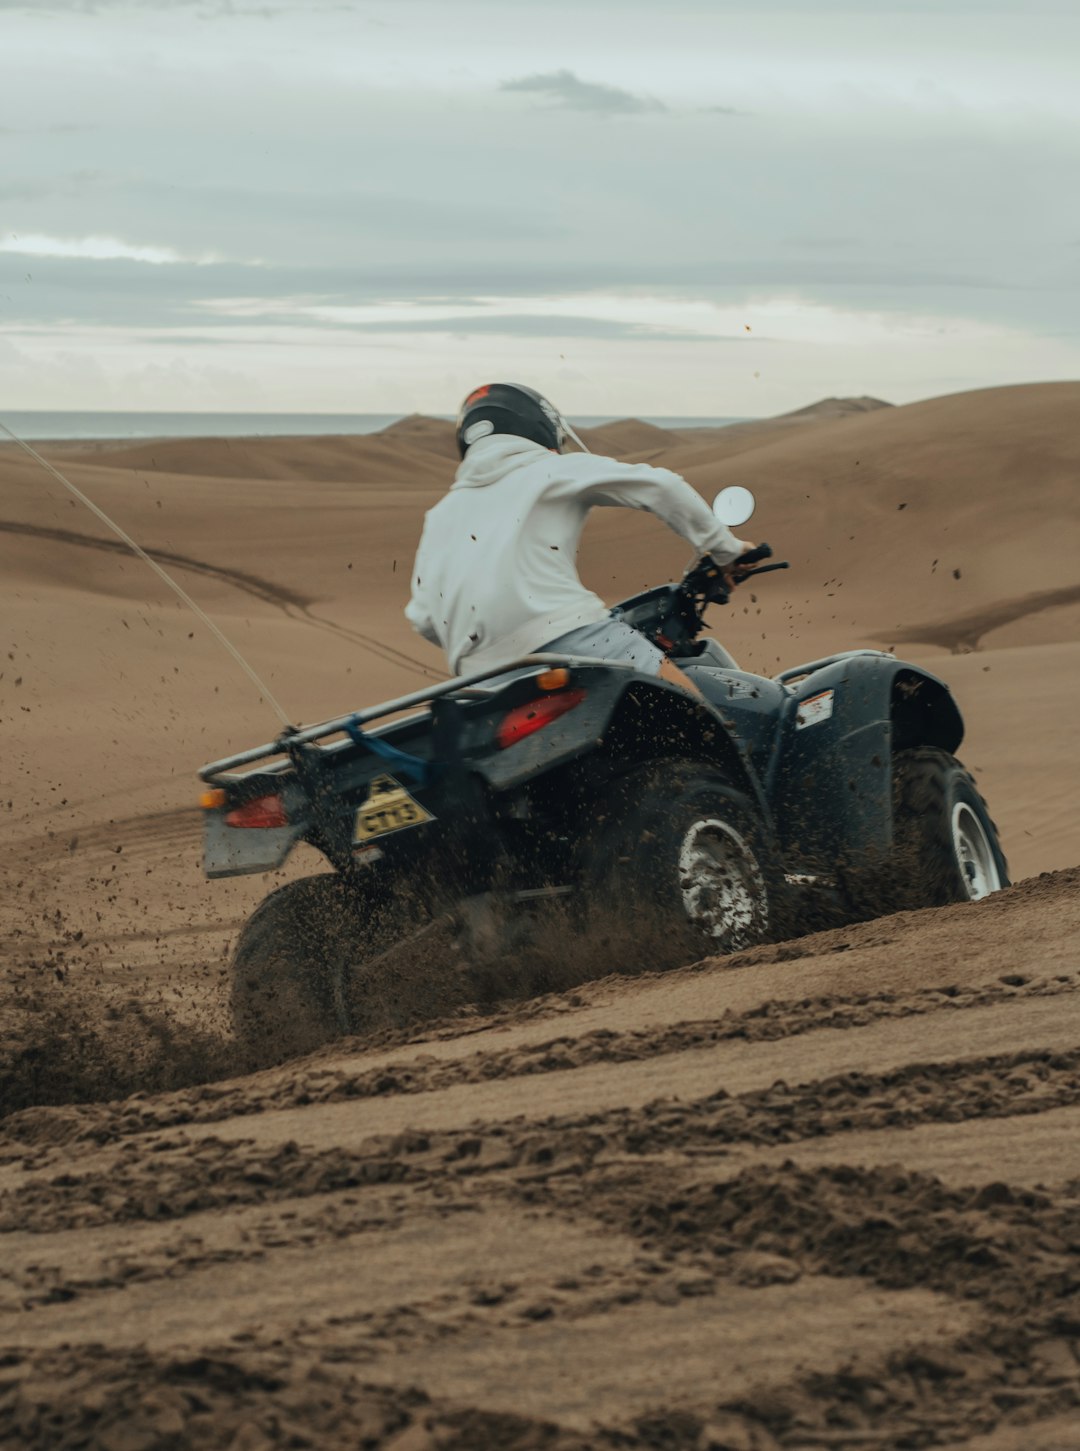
xmin=679 ymin=817 xmax=769 ymax=952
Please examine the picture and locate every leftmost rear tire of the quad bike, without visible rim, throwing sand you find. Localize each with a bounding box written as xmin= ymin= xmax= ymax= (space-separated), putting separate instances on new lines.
xmin=231 ymin=874 xmax=370 ymax=1062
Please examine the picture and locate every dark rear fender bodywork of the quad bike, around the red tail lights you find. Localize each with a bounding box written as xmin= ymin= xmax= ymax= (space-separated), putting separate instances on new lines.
xmin=200 ymin=654 xmax=768 ymax=876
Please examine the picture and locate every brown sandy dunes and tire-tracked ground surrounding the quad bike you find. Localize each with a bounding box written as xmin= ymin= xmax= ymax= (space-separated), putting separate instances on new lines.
xmin=0 ymin=385 xmax=1080 ymax=1451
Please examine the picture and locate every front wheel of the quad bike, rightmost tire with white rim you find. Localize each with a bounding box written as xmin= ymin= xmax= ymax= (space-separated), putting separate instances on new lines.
xmin=883 ymin=746 xmax=1009 ymax=910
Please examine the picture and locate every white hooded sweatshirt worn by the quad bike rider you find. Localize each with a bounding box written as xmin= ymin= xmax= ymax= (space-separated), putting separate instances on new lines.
xmin=405 ymin=434 xmax=743 ymax=675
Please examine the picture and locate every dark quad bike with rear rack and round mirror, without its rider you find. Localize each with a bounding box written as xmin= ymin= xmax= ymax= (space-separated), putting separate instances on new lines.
xmin=200 ymin=489 xmax=1009 ymax=1053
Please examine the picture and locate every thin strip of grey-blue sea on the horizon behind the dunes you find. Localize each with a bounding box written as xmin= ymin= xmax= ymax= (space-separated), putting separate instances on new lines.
xmin=0 ymin=408 xmax=750 ymax=443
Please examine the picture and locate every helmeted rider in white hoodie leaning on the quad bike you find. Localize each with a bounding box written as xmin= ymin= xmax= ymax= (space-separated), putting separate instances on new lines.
xmin=405 ymin=383 xmax=755 ymax=694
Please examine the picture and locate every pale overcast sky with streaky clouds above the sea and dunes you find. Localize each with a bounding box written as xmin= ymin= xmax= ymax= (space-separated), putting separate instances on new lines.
xmin=0 ymin=0 xmax=1080 ymax=416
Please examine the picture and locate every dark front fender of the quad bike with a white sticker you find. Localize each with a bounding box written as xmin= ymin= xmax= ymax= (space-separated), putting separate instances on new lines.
xmin=768 ymin=650 xmax=964 ymax=871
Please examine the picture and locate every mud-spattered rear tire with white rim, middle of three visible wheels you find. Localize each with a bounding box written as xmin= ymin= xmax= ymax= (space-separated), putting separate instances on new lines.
xmin=585 ymin=762 xmax=785 ymax=971
